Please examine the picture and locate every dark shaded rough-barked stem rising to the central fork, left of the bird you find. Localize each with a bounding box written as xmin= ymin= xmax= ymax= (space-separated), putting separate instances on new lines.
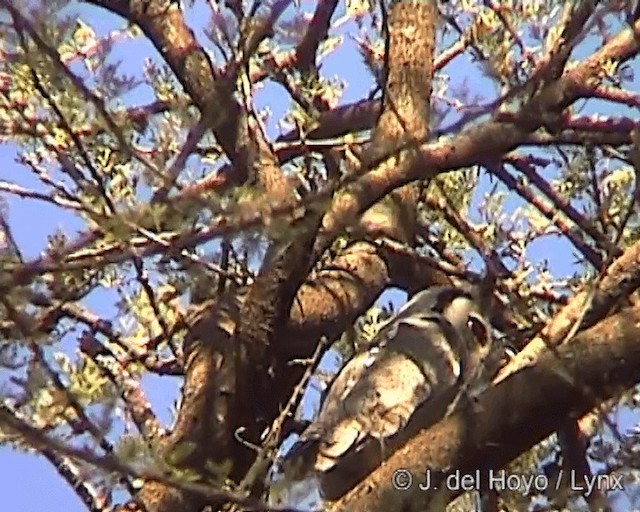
xmin=230 ymin=212 xmax=321 ymax=481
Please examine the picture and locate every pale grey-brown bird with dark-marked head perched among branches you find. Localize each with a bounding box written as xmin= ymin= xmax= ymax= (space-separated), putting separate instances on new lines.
xmin=283 ymin=286 xmax=492 ymax=481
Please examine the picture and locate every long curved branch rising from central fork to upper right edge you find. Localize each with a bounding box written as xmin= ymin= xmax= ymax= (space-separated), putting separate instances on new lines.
xmin=316 ymin=12 xmax=640 ymax=258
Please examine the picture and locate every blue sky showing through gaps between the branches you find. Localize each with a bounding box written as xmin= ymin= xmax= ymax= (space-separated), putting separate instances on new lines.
xmin=0 ymin=1 xmax=640 ymax=512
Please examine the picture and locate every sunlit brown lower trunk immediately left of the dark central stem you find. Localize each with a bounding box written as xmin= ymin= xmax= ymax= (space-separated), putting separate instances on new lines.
xmin=136 ymin=297 xmax=239 ymax=512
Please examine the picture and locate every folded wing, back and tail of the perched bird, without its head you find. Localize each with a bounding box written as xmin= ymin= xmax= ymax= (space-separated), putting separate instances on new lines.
xmin=285 ymin=316 xmax=464 ymax=480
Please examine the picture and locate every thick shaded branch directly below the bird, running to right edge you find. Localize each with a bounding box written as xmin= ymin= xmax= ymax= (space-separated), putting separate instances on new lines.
xmin=330 ymin=300 xmax=640 ymax=512
